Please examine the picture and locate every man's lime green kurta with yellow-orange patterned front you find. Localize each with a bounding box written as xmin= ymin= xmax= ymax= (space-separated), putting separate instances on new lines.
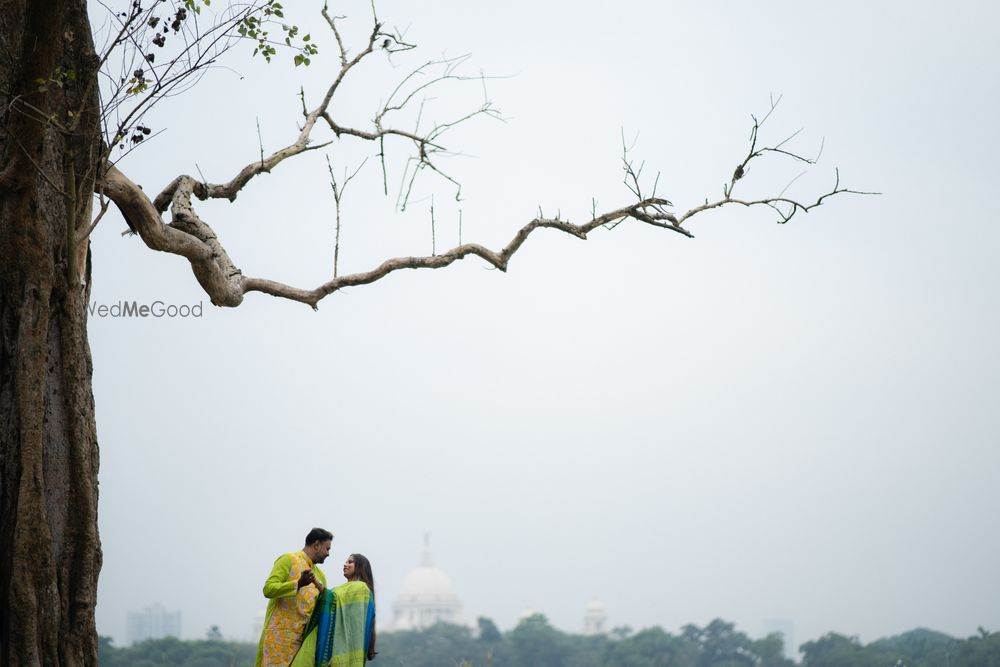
xmin=256 ymin=551 xmax=326 ymax=667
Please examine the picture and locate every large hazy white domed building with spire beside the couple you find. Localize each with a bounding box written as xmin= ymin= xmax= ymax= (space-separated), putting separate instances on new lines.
xmin=392 ymin=536 xmax=464 ymax=630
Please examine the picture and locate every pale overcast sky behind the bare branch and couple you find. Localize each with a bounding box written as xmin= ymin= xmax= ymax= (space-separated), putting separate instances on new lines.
xmin=90 ymin=0 xmax=1000 ymax=644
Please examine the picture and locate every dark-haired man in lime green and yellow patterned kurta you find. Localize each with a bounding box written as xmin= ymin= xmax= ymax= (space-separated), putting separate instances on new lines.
xmin=256 ymin=528 xmax=333 ymax=667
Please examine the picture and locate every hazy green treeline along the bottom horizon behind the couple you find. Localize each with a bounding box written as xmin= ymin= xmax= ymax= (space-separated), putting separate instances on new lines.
xmin=100 ymin=614 xmax=1000 ymax=667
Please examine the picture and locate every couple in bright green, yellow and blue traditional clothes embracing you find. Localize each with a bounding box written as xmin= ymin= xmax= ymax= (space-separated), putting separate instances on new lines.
xmin=256 ymin=528 xmax=375 ymax=667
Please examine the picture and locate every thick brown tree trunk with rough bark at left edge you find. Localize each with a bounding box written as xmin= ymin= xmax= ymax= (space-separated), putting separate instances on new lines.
xmin=0 ymin=0 xmax=101 ymax=667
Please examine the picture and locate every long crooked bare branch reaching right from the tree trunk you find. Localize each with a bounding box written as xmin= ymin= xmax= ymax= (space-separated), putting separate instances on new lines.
xmin=95 ymin=6 xmax=874 ymax=318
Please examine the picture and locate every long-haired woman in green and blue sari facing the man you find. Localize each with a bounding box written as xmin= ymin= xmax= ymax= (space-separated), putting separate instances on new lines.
xmin=292 ymin=554 xmax=376 ymax=667
